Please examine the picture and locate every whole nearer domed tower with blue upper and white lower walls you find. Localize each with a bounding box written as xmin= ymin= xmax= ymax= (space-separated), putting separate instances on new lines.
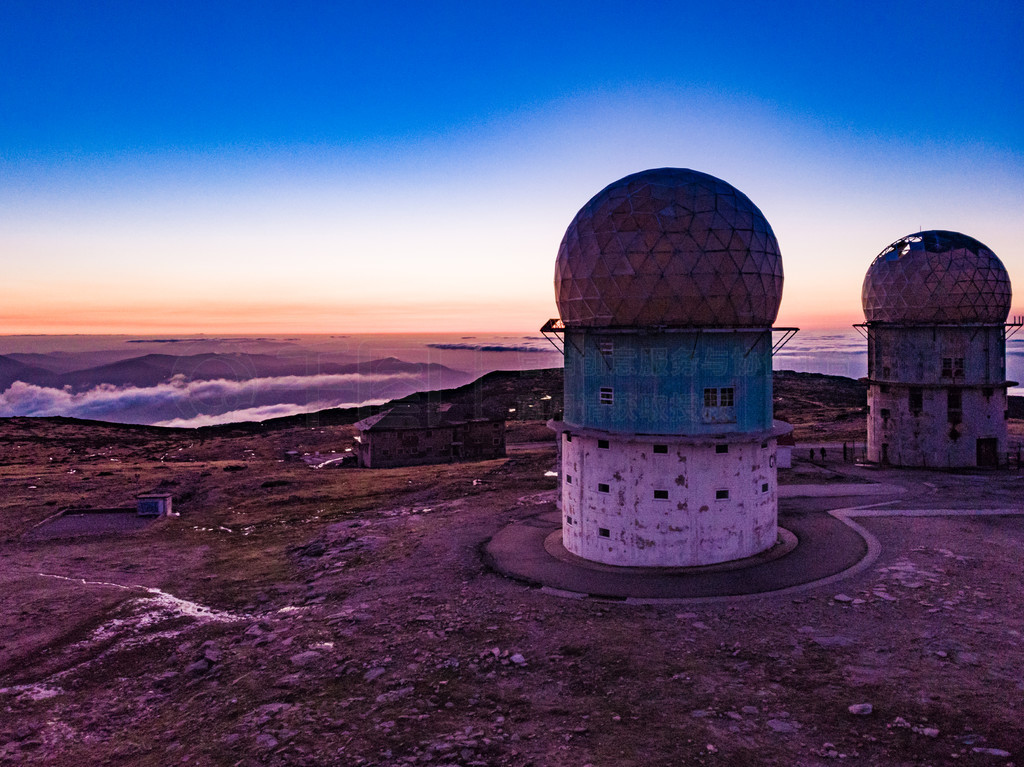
xmin=544 ymin=168 xmax=790 ymax=566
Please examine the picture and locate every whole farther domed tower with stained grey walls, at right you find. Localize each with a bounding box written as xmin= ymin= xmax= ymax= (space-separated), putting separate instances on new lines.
xmin=857 ymin=231 xmax=1016 ymax=467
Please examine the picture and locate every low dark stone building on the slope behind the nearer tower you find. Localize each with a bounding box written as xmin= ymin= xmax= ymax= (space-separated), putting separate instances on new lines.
xmin=355 ymin=404 xmax=505 ymax=469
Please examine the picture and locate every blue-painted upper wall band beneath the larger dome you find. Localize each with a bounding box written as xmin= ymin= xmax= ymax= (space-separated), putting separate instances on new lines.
xmin=564 ymin=329 xmax=772 ymax=434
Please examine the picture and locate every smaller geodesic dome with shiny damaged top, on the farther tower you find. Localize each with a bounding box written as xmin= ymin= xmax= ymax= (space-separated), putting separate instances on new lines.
xmin=860 ymin=230 xmax=1011 ymax=325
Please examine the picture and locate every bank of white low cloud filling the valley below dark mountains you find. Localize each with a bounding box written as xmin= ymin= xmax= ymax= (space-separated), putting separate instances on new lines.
xmin=0 ymin=373 xmax=426 ymax=426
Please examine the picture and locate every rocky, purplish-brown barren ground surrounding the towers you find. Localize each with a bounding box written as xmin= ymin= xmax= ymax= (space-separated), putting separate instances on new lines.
xmin=0 ymin=370 xmax=1024 ymax=767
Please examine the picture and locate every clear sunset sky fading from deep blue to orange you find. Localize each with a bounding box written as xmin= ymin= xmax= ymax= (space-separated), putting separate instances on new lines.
xmin=0 ymin=0 xmax=1024 ymax=334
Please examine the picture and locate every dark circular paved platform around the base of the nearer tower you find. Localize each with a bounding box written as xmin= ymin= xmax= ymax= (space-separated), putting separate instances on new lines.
xmin=484 ymin=503 xmax=868 ymax=602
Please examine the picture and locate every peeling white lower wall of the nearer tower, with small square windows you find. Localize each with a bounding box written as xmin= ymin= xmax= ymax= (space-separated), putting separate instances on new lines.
xmin=560 ymin=432 xmax=778 ymax=566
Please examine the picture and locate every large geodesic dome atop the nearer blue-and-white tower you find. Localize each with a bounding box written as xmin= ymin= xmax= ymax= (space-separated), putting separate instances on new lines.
xmin=555 ymin=168 xmax=782 ymax=328
